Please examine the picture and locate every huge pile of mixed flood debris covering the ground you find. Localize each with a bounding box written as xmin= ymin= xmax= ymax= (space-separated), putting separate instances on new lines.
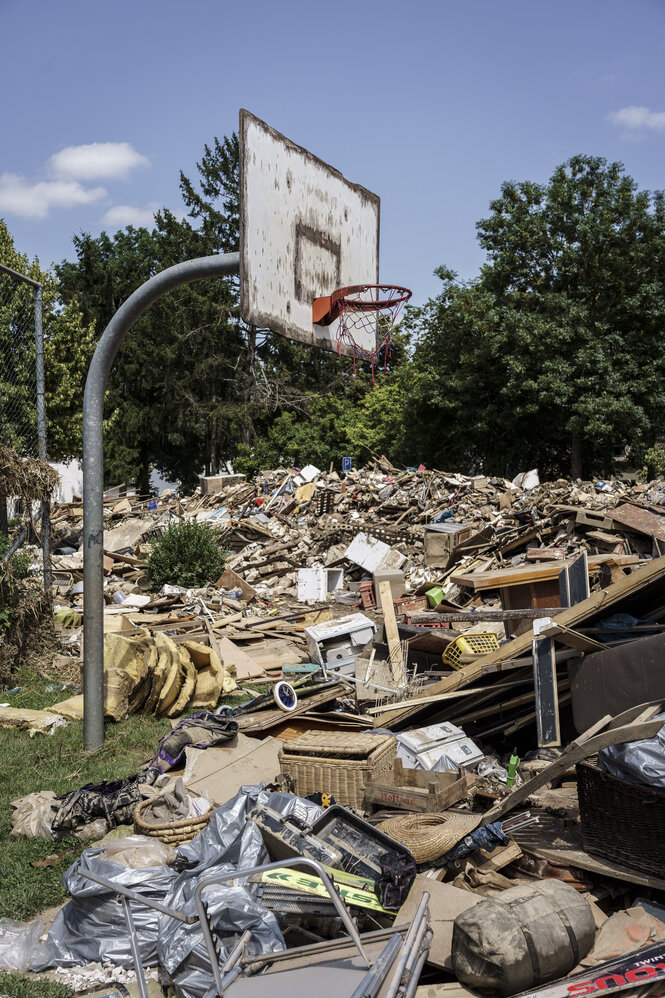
xmin=6 ymin=459 xmax=665 ymax=998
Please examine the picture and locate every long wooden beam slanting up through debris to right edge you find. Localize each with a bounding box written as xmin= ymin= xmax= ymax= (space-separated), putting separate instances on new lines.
xmin=381 ymin=555 xmax=665 ymax=724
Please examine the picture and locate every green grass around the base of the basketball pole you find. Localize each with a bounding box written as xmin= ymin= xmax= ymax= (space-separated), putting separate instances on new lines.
xmin=0 ymin=668 xmax=171 ymax=924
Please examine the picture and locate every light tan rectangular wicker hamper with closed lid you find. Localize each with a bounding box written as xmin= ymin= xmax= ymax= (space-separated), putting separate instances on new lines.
xmin=279 ymin=731 xmax=397 ymax=810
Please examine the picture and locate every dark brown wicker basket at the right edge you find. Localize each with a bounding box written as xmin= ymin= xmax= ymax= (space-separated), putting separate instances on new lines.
xmin=577 ymin=762 xmax=665 ymax=877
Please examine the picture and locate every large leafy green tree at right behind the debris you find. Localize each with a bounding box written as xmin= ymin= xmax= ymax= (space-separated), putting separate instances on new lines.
xmin=410 ymin=156 xmax=665 ymax=477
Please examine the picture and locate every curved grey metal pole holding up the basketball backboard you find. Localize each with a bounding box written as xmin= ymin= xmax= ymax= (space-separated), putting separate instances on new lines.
xmin=83 ymin=253 xmax=240 ymax=752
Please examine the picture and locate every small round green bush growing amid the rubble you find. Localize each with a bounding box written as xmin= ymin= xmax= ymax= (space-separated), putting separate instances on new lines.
xmin=147 ymin=520 xmax=228 ymax=591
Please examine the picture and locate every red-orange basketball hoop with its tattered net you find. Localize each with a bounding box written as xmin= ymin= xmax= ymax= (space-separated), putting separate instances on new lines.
xmin=312 ymin=284 xmax=411 ymax=381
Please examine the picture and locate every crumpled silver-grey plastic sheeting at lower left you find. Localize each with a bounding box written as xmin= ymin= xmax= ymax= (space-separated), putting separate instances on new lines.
xmin=32 ymin=787 xmax=290 ymax=998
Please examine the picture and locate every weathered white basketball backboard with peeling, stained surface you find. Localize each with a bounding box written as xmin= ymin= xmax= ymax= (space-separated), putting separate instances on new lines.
xmin=240 ymin=110 xmax=380 ymax=355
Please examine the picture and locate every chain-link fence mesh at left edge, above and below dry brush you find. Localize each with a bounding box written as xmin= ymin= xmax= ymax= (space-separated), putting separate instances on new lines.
xmin=0 ymin=264 xmax=51 ymax=588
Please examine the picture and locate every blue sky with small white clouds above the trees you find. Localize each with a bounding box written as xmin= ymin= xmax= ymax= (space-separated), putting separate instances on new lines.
xmin=0 ymin=0 xmax=665 ymax=302
